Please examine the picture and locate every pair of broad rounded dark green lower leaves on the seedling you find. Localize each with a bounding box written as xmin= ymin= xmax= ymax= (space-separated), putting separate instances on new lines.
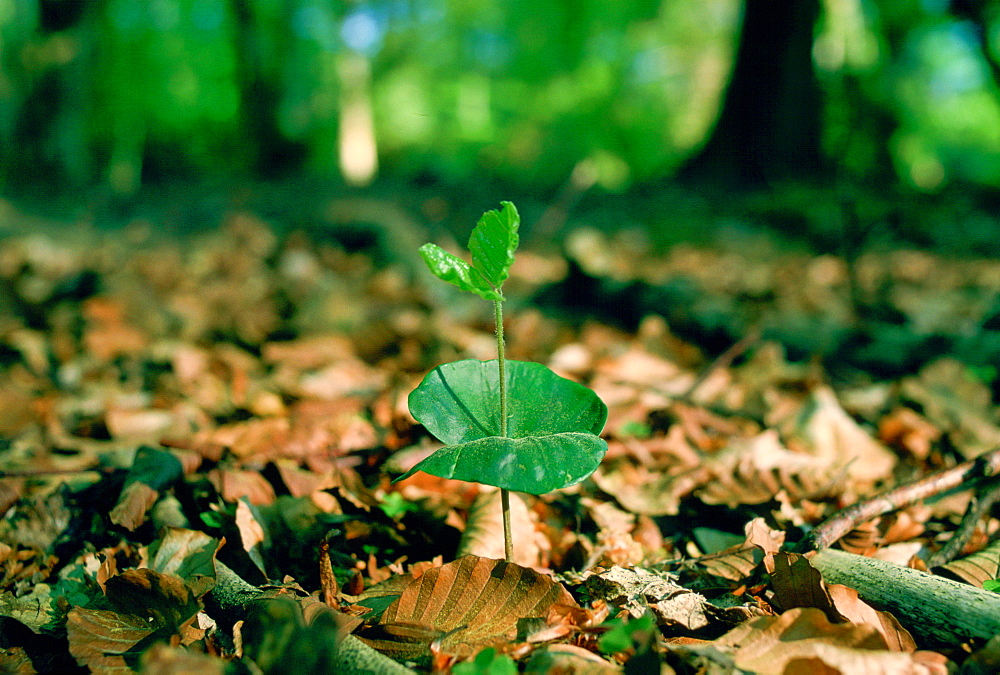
xmin=396 ymin=359 xmax=608 ymax=494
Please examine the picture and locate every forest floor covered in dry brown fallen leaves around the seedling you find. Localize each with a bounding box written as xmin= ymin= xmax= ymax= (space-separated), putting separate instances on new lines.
xmin=0 ymin=193 xmax=1000 ymax=675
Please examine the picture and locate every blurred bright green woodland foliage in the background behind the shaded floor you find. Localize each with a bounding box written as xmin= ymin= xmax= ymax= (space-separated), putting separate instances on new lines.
xmin=0 ymin=0 xmax=1000 ymax=192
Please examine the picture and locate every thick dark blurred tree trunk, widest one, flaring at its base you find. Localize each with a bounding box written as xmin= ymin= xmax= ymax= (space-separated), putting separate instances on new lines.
xmin=680 ymin=0 xmax=823 ymax=186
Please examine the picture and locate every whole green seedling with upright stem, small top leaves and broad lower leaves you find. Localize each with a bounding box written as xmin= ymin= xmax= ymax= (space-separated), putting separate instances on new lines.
xmin=396 ymin=202 xmax=608 ymax=561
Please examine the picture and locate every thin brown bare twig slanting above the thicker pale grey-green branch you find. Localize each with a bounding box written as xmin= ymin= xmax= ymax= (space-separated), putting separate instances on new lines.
xmin=796 ymin=448 xmax=1000 ymax=552
